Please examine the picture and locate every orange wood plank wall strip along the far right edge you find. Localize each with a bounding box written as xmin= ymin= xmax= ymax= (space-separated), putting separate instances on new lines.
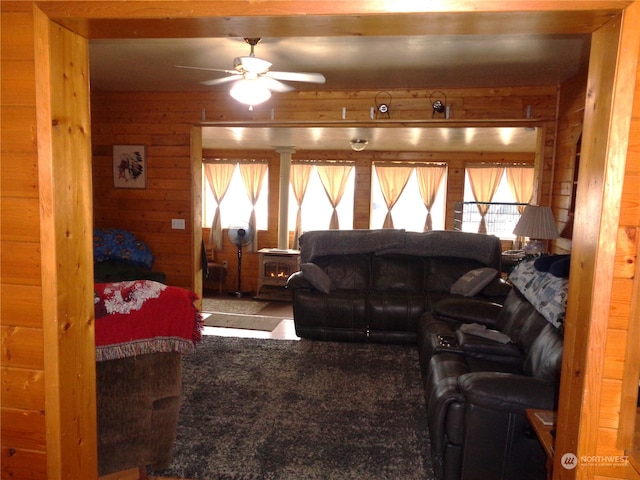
xmin=594 ymin=4 xmax=640 ymax=479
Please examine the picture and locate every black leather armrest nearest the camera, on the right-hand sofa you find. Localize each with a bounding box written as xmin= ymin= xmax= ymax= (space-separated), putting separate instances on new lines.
xmin=458 ymin=372 xmax=557 ymax=414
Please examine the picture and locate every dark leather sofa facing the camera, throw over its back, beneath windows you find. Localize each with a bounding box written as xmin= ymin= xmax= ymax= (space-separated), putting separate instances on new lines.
xmin=287 ymin=230 xmax=508 ymax=343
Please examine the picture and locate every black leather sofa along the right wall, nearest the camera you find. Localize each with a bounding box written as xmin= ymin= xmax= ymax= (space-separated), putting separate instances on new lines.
xmin=418 ymin=288 xmax=563 ymax=480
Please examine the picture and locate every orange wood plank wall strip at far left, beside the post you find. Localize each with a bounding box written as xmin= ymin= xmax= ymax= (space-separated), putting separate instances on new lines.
xmin=0 ymin=2 xmax=47 ymax=478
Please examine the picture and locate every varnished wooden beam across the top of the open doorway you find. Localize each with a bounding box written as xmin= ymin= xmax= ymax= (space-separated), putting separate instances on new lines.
xmin=33 ymin=0 xmax=631 ymax=38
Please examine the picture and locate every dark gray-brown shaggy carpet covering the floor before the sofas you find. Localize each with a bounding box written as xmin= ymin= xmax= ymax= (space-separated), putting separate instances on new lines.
xmin=152 ymin=336 xmax=433 ymax=480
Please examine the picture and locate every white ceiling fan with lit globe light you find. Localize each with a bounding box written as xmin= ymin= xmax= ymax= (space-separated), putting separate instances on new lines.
xmin=176 ymin=38 xmax=326 ymax=105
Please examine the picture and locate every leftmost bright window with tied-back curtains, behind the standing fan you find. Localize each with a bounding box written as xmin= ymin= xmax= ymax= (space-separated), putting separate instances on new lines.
xmin=202 ymin=162 xmax=269 ymax=230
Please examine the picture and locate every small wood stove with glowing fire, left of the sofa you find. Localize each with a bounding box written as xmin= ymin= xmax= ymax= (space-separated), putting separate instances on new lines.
xmin=256 ymin=248 xmax=300 ymax=300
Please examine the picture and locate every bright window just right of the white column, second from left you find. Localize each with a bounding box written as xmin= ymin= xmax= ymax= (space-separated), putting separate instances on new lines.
xmin=289 ymin=163 xmax=355 ymax=232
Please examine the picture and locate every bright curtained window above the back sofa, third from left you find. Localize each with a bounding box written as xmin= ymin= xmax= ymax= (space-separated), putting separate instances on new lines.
xmin=370 ymin=164 xmax=447 ymax=232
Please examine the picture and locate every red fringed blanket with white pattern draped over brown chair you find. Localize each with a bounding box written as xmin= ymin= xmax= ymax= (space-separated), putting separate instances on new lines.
xmin=95 ymin=280 xmax=202 ymax=361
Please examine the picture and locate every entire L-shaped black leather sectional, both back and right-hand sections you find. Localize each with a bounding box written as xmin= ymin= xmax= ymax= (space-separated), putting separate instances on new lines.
xmin=287 ymin=230 xmax=562 ymax=480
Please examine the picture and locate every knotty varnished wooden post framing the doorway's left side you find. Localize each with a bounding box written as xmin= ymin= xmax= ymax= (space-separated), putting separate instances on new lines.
xmin=35 ymin=12 xmax=98 ymax=480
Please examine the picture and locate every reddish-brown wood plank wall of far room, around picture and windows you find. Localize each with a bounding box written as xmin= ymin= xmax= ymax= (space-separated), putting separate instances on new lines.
xmin=92 ymin=86 xmax=557 ymax=291
